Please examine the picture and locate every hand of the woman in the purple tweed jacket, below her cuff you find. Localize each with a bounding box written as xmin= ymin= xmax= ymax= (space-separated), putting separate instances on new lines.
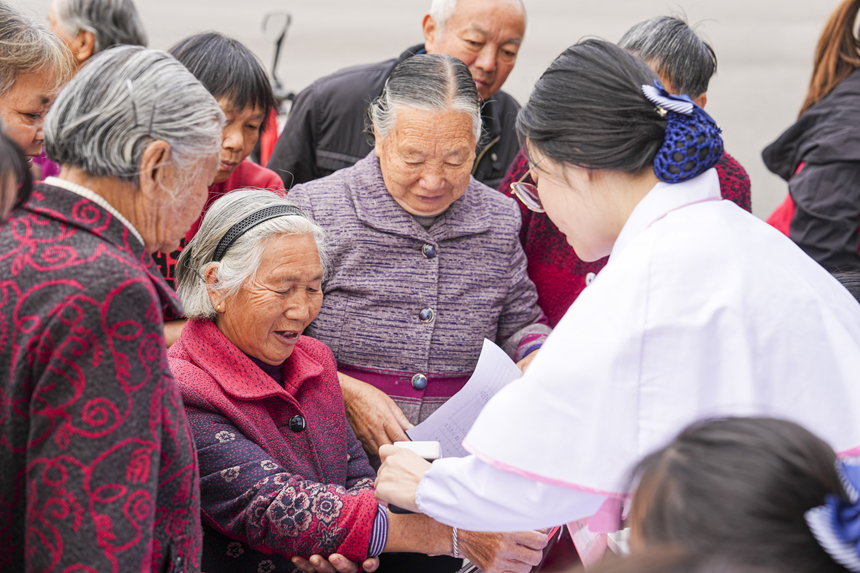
xmin=337 ymin=372 xmax=412 ymax=455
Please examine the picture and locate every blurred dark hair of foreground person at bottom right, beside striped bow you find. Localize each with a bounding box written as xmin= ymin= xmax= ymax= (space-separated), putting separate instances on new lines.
xmin=630 ymin=418 xmax=846 ymax=573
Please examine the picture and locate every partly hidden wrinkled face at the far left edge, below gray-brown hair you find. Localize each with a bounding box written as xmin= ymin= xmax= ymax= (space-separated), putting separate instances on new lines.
xmin=0 ymin=71 xmax=57 ymax=159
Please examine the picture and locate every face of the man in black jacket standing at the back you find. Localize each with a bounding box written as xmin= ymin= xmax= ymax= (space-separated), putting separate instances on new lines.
xmin=424 ymin=0 xmax=526 ymax=100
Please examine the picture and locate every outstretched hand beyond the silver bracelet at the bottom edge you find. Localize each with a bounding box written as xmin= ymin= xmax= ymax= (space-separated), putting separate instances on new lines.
xmin=457 ymin=530 xmax=549 ymax=573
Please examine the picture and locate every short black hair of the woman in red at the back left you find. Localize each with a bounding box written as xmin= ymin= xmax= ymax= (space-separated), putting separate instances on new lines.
xmin=170 ymin=32 xmax=276 ymax=133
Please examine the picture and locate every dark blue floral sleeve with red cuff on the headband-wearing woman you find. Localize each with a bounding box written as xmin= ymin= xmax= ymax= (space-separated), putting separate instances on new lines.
xmin=186 ymin=407 xmax=379 ymax=561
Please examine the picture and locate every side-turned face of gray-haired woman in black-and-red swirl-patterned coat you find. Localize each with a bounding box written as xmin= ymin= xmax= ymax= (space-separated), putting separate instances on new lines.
xmin=153 ymin=156 xmax=218 ymax=253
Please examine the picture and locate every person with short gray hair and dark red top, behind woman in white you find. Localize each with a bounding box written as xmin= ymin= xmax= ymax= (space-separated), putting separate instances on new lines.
xmin=499 ymin=16 xmax=750 ymax=327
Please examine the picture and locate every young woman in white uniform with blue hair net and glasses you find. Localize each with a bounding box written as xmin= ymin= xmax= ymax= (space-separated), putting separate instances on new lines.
xmin=377 ymin=40 xmax=860 ymax=531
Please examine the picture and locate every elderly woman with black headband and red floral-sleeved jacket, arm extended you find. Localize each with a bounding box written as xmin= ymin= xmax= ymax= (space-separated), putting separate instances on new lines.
xmin=169 ymin=190 xmax=546 ymax=573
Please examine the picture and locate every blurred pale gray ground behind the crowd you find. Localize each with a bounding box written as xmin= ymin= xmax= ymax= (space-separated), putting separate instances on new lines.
xmin=11 ymin=0 xmax=839 ymax=218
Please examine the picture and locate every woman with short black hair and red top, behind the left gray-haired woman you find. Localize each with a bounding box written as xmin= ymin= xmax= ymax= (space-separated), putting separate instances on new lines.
xmin=160 ymin=32 xmax=286 ymax=346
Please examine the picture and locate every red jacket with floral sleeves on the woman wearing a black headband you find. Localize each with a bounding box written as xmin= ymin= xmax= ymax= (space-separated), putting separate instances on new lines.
xmin=169 ymin=320 xmax=379 ymax=573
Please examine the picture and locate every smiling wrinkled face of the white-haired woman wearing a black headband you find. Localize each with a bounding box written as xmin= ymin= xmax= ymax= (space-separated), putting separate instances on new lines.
xmin=210 ymin=235 xmax=323 ymax=365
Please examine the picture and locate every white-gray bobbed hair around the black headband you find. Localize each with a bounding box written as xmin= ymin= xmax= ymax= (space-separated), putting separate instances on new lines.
xmin=176 ymin=189 xmax=328 ymax=319
